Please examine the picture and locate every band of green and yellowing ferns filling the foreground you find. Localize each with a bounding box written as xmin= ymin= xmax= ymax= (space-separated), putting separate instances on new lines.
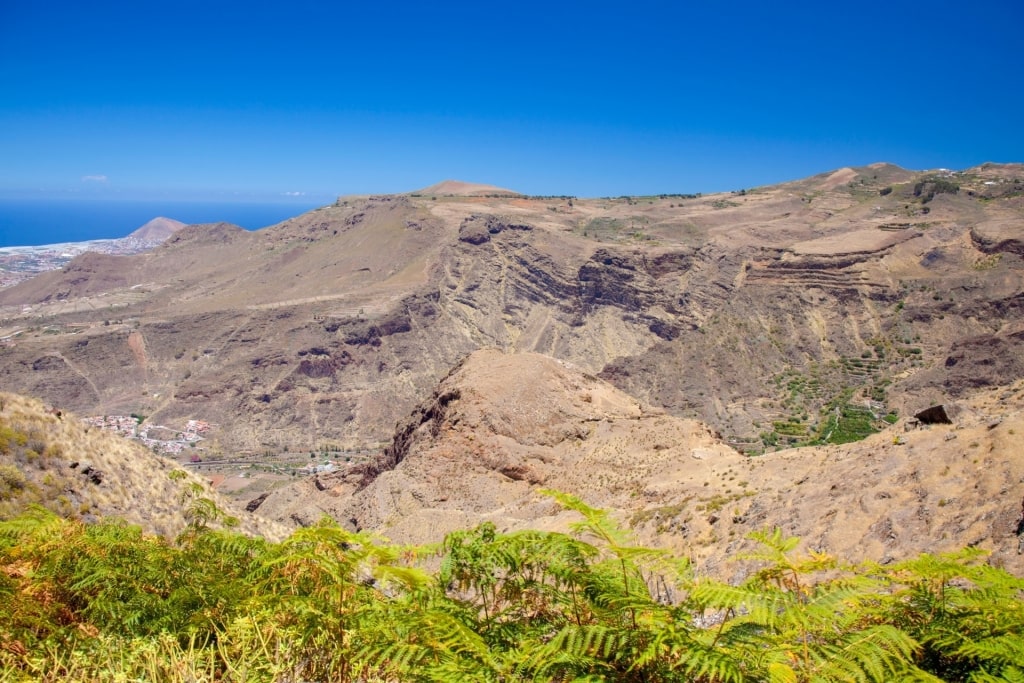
xmin=0 ymin=493 xmax=1024 ymax=683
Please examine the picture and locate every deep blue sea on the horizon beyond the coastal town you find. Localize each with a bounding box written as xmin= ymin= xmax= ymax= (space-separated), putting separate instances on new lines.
xmin=0 ymin=200 xmax=322 ymax=247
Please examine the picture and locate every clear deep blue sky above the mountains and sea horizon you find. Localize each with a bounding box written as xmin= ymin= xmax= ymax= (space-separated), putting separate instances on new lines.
xmin=0 ymin=0 xmax=1024 ymax=202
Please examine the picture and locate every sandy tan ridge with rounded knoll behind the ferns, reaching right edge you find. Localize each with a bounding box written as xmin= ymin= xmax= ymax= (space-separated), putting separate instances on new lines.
xmin=253 ymin=350 xmax=1024 ymax=574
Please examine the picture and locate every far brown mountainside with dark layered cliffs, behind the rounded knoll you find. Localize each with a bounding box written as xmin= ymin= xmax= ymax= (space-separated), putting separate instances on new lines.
xmin=0 ymin=166 xmax=1024 ymax=453
